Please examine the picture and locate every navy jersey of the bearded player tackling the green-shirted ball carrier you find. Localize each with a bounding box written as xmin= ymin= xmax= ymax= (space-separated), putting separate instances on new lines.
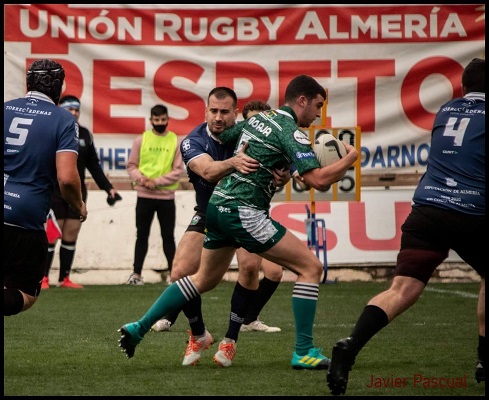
xmin=180 ymin=123 xmax=234 ymax=213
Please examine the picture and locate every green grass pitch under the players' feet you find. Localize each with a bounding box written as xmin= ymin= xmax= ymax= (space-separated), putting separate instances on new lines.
xmin=4 ymin=282 xmax=485 ymax=397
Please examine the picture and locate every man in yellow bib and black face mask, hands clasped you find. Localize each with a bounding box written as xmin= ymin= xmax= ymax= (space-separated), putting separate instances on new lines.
xmin=126 ymin=104 xmax=185 ymax=285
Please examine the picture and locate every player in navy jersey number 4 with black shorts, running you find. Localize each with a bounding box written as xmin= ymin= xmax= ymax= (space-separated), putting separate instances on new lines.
xmin=327 ymin=58 xmax=487 ymax=395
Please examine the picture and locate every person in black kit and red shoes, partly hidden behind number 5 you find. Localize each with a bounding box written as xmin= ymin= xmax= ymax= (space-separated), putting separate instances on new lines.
xmin=41 ymin=95 xmax=121 ymax=289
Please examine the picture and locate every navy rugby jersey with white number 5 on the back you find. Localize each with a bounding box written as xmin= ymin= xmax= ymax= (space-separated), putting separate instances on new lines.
xmin=3 ymin=91 xmax=78 ymax=230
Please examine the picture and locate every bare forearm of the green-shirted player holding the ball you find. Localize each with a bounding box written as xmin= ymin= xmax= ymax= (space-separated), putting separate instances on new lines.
xmin=301 ymin=142 xmax=358 ymax=191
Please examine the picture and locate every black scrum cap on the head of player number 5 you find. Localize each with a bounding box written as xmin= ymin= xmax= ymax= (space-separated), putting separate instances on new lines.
xmin=26 ymin=59 xmax=65 ymax=105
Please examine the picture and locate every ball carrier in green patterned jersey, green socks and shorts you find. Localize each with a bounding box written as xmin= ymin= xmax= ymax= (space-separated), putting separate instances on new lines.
xmin=119 ymin=75 xmax=358 ymax=370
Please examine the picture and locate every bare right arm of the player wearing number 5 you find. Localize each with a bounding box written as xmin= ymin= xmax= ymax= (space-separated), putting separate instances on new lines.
xmin=56 ymin=151 xmax=87 ymax=221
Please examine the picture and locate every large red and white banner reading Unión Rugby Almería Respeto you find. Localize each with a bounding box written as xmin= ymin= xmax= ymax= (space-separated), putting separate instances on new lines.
xmin=4 ymin=4 xmax=485 ymax=175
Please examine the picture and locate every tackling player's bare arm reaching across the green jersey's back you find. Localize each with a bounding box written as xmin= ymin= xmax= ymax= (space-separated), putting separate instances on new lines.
xmin=188 ymin=143 xmax=260 ymax=182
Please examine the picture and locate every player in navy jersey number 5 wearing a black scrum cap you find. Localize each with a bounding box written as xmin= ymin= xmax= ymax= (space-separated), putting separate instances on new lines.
xmin=3 ymin=59 xmax=87 ymax=316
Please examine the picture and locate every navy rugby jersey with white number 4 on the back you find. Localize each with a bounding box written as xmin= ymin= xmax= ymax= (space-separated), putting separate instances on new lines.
xmin=413 ymin=93 xmax=486 ymax=215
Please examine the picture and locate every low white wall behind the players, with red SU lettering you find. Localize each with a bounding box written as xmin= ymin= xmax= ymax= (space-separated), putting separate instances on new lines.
xmin=43 ymin=187 xmax=478 ymax=284
